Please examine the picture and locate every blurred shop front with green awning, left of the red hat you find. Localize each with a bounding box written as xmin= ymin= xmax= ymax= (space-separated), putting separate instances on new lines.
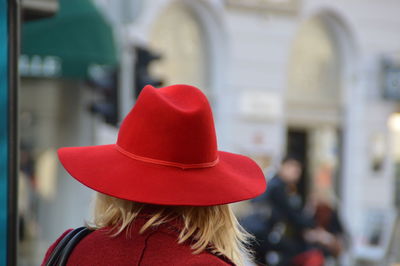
xmin=18 ymin=0 xmax=118 ymax=265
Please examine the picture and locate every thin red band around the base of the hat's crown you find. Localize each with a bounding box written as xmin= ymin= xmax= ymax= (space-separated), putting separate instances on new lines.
xmin=115 ymin=144 xmax=219 ymax=169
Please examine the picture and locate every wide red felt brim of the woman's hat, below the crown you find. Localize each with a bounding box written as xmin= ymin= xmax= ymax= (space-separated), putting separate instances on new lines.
xmin=58 ymin=144 xmax=266 ymax=206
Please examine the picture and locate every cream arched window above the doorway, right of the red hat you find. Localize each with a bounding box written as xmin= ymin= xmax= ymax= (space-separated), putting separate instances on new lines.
xmin=287 ymin=18 xmax=340 ymax=110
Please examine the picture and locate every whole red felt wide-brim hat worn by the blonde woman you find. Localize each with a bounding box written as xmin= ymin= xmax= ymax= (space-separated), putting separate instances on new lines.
xmin=58 ymin=85 xmax=266 ymax=206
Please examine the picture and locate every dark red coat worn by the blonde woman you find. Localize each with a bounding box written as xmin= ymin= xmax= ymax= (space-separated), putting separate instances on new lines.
xmin=42 ymin=217 xmax=234 ymax=266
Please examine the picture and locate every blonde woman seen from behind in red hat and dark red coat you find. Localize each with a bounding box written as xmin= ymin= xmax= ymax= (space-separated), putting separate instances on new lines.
xmin=43 ymin=85 xmax=266 ymax=265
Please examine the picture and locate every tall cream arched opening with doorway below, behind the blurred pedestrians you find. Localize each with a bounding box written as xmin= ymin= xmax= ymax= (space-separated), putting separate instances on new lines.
xmin=286 ymin=16 xmax=343 ymax=204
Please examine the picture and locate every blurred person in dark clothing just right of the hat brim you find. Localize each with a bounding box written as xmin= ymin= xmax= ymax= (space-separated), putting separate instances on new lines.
xmin=244 ymin=157 xmax=315 ymax=266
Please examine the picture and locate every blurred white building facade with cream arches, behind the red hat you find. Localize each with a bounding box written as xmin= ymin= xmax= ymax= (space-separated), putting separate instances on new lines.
xmin=97 ymin=0 xmax=400 ymax=262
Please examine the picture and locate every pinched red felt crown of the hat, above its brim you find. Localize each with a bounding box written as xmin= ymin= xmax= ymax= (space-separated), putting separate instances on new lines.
xmin=117 ymin=85 xmax=218 ymax=164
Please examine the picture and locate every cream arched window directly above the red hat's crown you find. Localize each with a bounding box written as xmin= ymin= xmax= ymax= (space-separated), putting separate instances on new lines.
xmin=150 ymin=3 xmax=209 ymax=94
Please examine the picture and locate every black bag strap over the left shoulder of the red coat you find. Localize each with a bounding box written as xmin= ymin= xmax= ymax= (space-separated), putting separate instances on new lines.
xmin=46 ymin=226 xmax=92 ymax=266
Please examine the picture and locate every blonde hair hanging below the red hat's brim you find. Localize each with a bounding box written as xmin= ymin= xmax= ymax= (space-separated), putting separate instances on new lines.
xmin=89 ymin=193 xmax=252 ymax=265
